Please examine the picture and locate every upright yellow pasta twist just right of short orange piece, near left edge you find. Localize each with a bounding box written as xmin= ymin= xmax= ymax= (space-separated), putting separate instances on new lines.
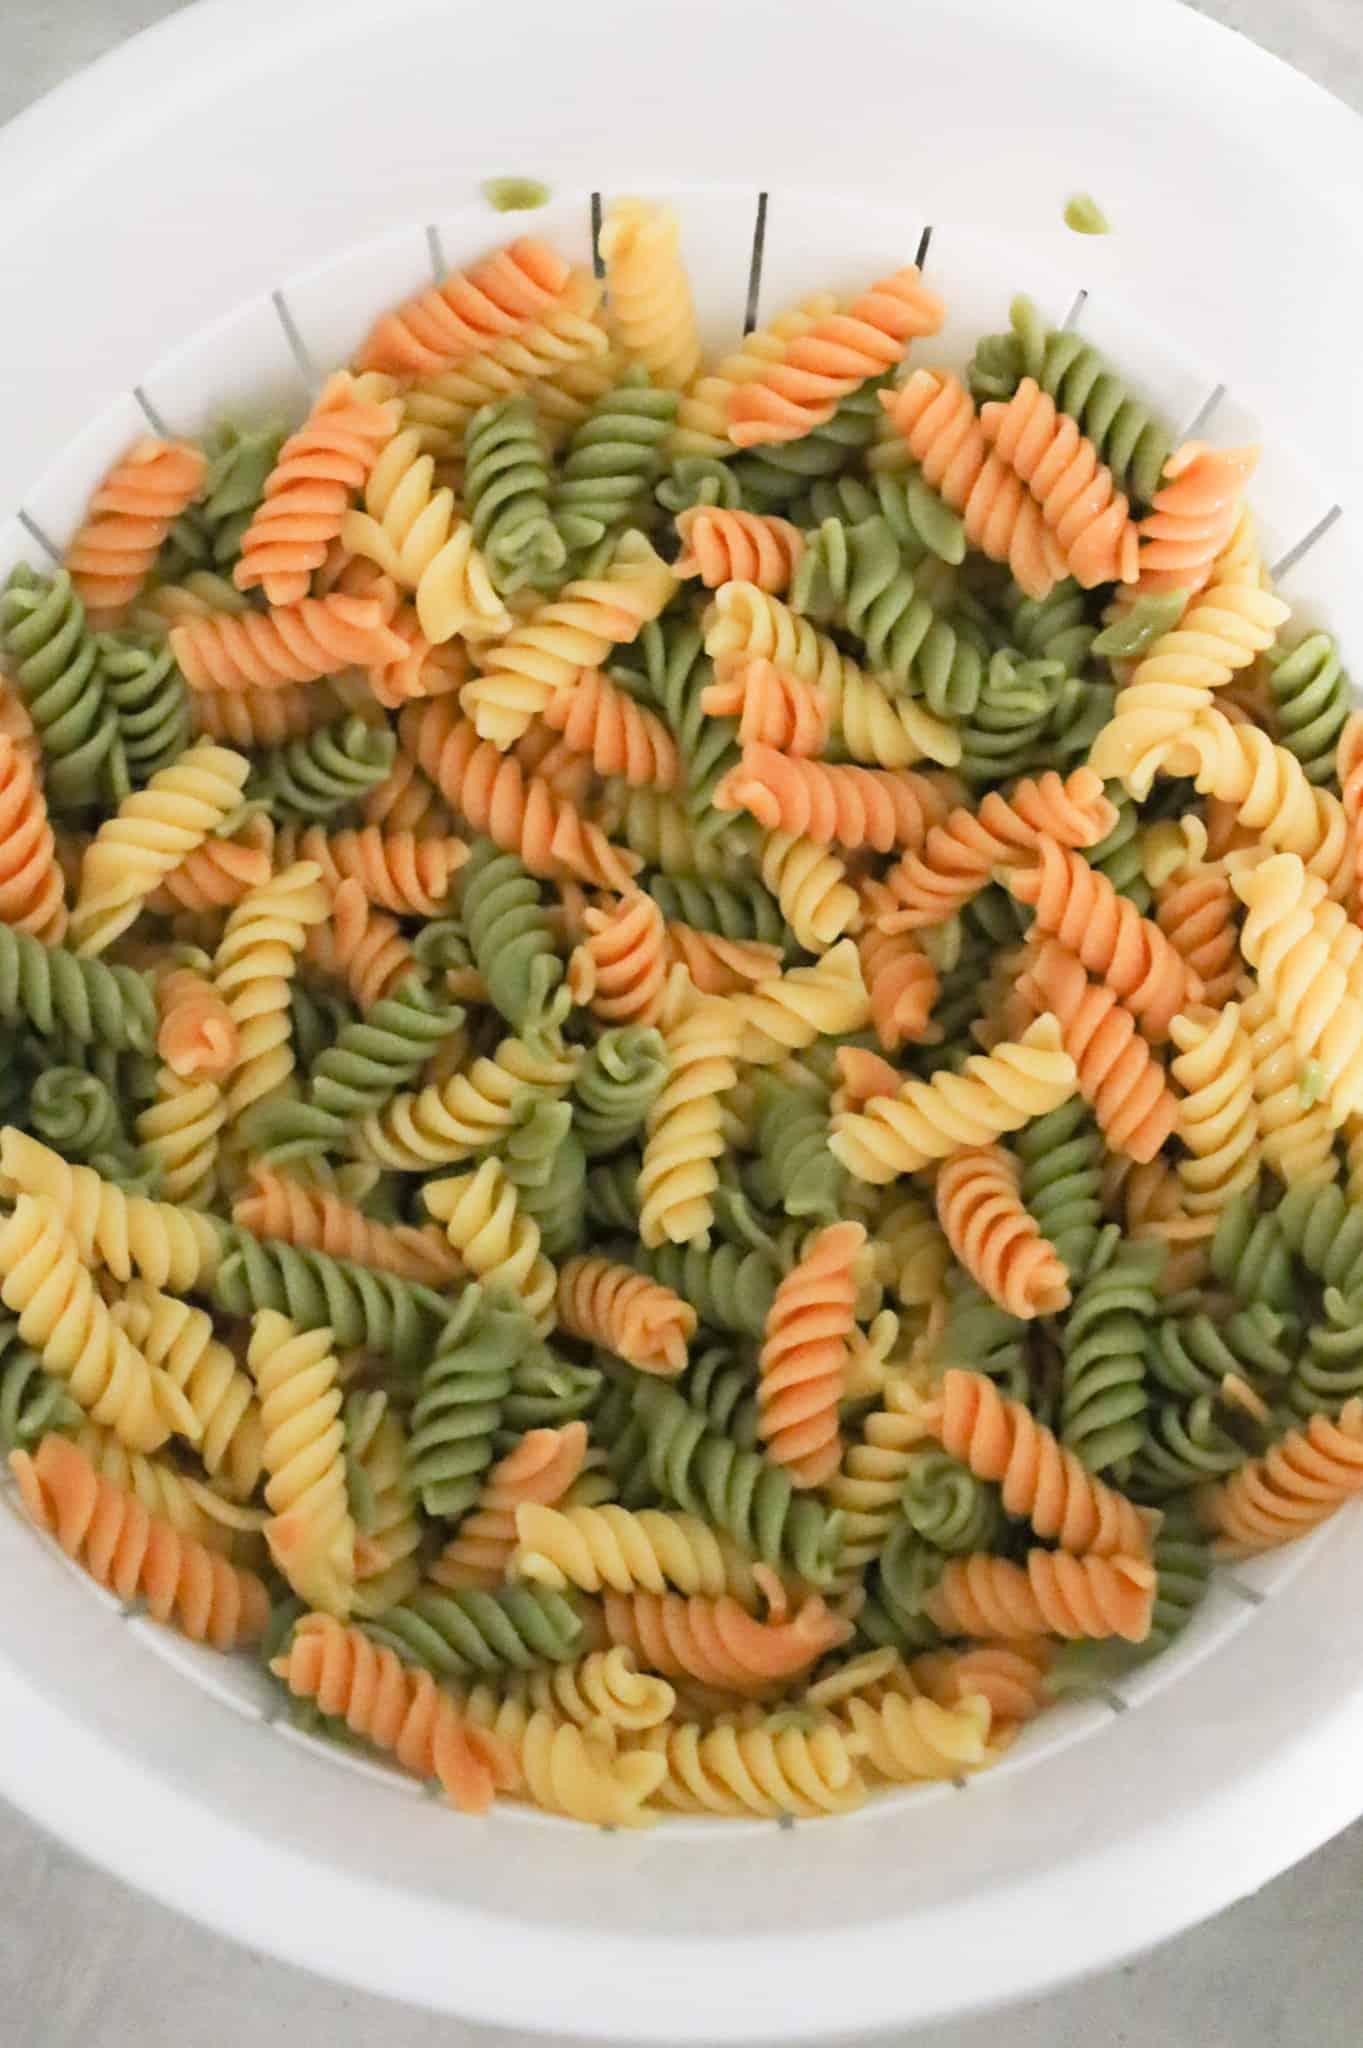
xmin=213 ymin=860 xmax=327 ymax=1122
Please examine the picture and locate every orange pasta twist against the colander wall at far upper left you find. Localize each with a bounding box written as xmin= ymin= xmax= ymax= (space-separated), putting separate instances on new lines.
xmin=65 ymin=436 xmax=207 ymax=627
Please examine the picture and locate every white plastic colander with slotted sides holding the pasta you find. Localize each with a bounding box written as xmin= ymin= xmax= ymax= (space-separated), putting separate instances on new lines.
xmin=0 ymin=0 xmax=1363 ymax=2042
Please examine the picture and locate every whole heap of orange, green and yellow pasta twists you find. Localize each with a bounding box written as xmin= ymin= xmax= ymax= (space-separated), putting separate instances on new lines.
xmin=0 ymin=199 xmax=1363 ymax=1825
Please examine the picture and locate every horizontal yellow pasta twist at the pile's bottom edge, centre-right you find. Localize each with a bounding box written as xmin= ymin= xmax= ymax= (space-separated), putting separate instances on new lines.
xmin=645 ymin=1716 xmax=866 ymax=1821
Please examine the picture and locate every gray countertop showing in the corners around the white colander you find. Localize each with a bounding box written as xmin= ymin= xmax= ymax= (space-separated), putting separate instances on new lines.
xmin=0 ymin=0 xmax=1363 ymax=2048
